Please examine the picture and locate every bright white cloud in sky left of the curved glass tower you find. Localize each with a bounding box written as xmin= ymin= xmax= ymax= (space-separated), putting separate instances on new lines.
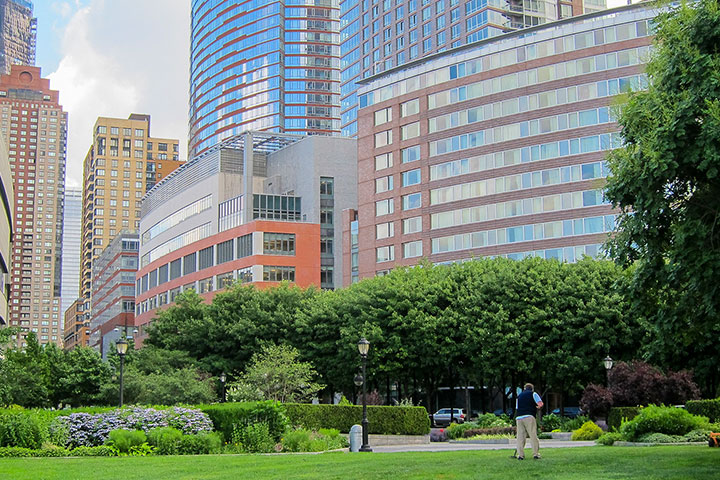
xmin=48 ymin=0 xmax=190 ymax=191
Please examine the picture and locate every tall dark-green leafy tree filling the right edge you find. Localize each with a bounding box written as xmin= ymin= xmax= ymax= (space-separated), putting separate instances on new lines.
xmin=606 ymin=0 xmax=720 ymax=393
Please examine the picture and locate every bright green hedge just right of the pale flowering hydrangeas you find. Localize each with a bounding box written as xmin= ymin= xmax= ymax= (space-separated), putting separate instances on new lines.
xmin=196 ymin=400 xmax=288 ymax=442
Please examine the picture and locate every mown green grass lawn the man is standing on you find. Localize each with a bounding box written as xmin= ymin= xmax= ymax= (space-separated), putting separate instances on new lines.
xmin=0 ymin=446 xmax=720 ymax=480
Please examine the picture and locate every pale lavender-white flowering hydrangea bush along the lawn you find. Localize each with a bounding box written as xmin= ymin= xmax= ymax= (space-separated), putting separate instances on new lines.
xmin=51 ymin=407 xmax=212 ymax=448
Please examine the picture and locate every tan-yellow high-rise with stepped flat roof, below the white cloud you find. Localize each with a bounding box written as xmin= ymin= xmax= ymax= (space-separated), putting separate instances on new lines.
xmin=80 ymin=114 xmax=185 ymax=304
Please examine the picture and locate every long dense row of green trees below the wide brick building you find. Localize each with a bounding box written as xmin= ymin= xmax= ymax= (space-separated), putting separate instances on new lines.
xmin=146 ymin=258 xmax=644 ymax=400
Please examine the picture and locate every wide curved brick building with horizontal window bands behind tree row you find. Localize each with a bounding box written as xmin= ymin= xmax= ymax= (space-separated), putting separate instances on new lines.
xmin=344 ymin=4 xmax=657 ymax=284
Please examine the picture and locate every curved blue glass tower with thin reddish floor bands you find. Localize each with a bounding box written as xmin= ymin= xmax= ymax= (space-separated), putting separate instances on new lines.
xmin=189 ymin=0 xmax=340 ymax=157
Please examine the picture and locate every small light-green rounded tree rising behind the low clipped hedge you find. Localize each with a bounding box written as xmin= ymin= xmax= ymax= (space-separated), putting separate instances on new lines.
xmin=228 ymin=345 xmax=324 ymax=402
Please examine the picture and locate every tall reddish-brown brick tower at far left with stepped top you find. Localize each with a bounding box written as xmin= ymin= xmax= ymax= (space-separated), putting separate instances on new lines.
xmin=0 ymin=65 xmax=67 ymax=347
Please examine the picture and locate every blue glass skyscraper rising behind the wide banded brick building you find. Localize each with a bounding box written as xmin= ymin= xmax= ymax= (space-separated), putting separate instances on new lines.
xmin=340 ymin=0 xmax=606 ymax=136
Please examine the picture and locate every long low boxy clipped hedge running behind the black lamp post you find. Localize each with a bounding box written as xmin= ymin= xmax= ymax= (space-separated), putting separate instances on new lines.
xmin=283 ymin=403 xmax=430 ymax=435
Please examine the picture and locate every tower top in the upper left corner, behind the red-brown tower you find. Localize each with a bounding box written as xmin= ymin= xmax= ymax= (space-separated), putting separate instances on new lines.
xmin=0 ymin=0 xmax=37 ymax=74
